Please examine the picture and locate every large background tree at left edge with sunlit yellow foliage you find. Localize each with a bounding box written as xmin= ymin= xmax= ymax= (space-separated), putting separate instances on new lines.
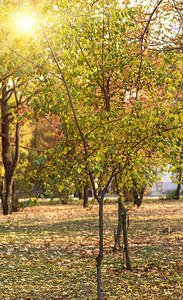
xmin=0 ymin=1 xmax=56 ymax=214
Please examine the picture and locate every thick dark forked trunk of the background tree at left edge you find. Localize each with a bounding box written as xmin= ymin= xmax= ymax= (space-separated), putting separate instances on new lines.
xmin=1 ymin=83 xmax=20 ymax=215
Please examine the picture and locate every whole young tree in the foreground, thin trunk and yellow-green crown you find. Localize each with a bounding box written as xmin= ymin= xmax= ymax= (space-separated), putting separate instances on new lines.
xmin=26 ymin=2 xmax=182 ymax=299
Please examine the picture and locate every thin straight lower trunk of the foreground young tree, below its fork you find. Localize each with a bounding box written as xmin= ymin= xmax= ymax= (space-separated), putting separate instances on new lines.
xmin=96 ymin=197 xmax=104 ymax=300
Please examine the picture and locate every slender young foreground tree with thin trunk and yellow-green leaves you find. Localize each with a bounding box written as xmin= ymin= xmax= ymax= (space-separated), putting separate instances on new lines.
xmin=27 ymin=4 xmax=182 ymax=299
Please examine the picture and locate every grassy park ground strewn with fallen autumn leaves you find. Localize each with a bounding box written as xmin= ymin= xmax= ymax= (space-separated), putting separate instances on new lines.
xmin=0 ymin=200 xmax=183 ymax=300
